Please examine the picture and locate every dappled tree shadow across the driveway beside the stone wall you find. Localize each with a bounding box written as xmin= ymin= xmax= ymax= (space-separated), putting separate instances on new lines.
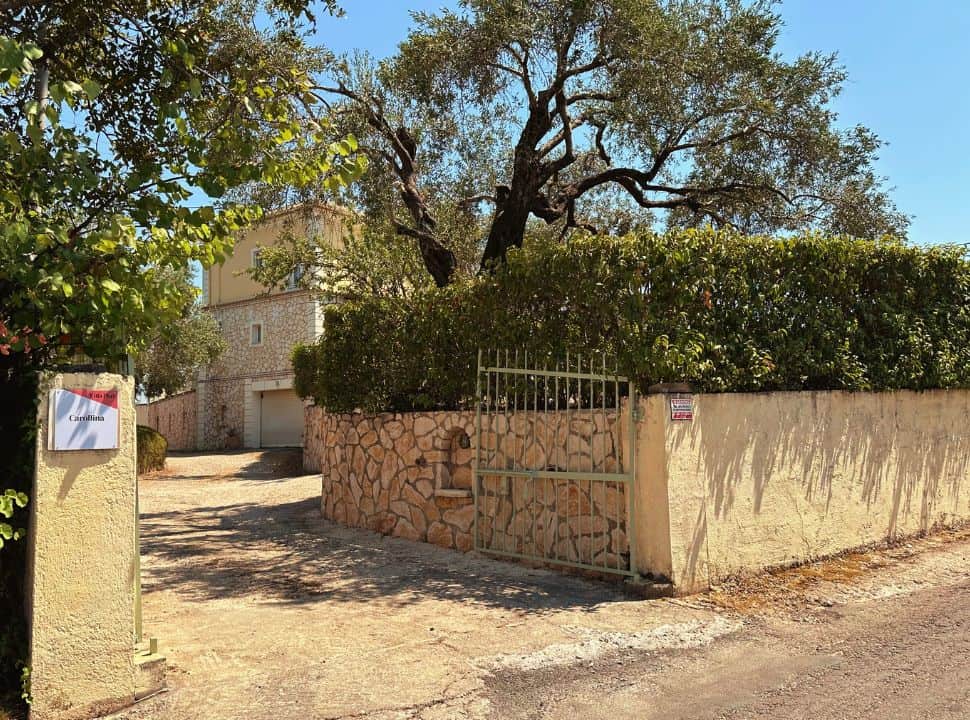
xmin=141 ymin=497 xmax=625 ymax=614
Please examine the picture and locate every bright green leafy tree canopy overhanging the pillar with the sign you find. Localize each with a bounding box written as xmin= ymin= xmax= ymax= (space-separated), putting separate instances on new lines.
xmin=0 ymin=0 xmax=362 ymax=365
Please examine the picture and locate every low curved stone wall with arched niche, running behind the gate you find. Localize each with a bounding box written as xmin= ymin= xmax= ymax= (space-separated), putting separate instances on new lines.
xmin=304 ymin=408 xmax=629 ymax=568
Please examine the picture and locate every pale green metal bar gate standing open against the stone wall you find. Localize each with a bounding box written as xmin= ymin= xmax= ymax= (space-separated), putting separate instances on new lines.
xmin=473 ymin=350 xmax=637 ymax=575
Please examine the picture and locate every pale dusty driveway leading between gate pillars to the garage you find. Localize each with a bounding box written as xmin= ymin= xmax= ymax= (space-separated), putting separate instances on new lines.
xmin=121 ymin=453 xmax=720 ymax=720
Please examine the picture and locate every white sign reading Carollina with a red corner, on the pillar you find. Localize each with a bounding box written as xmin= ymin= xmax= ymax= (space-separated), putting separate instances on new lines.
xmin=48 ymin=388 xmax=121 ymax=450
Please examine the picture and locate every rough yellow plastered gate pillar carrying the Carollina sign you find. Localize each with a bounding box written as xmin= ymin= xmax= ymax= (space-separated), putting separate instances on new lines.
xmin=27 ymin=374 xmax=137 ymax=720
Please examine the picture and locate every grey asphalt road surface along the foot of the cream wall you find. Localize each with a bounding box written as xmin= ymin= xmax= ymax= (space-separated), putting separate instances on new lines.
xmin=489 ymin=579 xmax=970 ymax=720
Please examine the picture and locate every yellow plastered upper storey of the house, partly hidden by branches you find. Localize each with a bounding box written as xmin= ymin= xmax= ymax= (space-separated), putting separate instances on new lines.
xmin=205 ymin=205 xmax=347 ymax=305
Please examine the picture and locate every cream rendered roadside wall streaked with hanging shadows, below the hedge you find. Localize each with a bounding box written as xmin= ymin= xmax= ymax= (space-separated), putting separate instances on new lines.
xmin=637 ymin=390 xmax=970 ymax=592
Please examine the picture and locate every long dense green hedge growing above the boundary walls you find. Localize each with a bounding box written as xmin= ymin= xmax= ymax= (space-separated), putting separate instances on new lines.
xmin=293 ymin=230 xmax=970 ymax=411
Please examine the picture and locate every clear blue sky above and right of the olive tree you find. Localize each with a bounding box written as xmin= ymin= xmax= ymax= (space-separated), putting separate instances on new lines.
xmin=317 ymin=0 xmax=970 ymax=244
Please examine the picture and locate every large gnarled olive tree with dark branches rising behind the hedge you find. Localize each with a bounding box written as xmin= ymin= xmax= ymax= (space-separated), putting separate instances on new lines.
xmin=320 ymin=0 xmax=908 ymax=285
